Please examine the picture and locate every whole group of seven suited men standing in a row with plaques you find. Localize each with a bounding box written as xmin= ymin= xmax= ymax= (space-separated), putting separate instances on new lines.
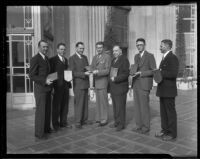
xmin=29 ymin=38 xmax=178 ymax=141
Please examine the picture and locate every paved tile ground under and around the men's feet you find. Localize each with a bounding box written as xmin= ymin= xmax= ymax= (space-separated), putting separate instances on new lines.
xmin=7 ymin=88 xmax=197 ymax=157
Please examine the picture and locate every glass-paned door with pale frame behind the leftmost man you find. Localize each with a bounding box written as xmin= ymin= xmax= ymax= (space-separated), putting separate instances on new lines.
xmin=7 ymin=34 xmax=34 ymax=109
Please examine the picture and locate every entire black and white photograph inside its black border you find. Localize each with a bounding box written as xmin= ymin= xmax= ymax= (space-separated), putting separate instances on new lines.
xmin=4 ymin=2 xmax=198 ymax=157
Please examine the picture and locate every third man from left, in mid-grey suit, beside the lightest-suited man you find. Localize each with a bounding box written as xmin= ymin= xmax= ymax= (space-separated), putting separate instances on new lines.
xmin=69 ymin=42 xmax=89 ymax=129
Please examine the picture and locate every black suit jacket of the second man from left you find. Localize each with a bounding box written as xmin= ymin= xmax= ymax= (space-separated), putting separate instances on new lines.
xmin=50 ymin=55 xmax=71 ymax=89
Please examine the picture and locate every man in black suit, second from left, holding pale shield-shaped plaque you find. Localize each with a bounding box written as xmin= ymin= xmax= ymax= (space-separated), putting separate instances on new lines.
xmin=50 ymin=43 xmax=71 ymax=131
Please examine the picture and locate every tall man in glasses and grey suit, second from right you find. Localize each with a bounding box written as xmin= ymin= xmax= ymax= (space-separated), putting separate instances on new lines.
xmin=130 ymin=38 xmax=156 ymax=133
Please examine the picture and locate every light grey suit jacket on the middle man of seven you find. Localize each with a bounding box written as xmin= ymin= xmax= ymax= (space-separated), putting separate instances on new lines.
xmin=91 ymin=53 xmax=111 ymax=89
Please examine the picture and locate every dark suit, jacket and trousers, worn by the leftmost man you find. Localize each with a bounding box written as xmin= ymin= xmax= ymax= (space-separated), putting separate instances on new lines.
xmin=29 ymin=53 xmax=51 ymax=137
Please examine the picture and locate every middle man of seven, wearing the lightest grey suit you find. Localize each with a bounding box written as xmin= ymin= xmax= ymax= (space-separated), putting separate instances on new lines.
xmin=91 ymin=41 xmax=111 ymax=126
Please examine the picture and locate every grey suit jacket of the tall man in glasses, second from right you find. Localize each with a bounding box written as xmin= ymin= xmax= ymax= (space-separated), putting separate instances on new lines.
xmin=133 ymin=51 xmax=156 ymax=90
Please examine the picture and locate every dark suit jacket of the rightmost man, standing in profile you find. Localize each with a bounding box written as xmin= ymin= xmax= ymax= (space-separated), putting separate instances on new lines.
xmin=156 ymin=51 xmax=179 ymax=97
